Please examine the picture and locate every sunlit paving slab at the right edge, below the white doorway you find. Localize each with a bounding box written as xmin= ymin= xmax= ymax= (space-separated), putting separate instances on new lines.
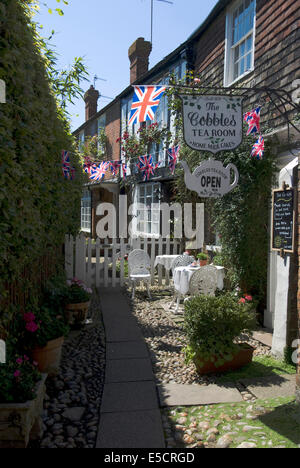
xmin=240 ymin=374 xmax=296 ymax=399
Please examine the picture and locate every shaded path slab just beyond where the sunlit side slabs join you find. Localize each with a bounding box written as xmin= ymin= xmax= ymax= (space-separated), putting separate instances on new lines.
xmin=105 ymin=358 xmax=154 ymax=383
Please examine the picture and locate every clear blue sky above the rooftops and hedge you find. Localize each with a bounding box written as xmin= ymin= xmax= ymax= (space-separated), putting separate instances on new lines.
xmin=37 ymin=0 xmax=218 ymax=130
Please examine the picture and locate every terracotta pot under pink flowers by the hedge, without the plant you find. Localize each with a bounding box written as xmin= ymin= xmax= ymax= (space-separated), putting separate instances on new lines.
xmin=31 ymin=336 xmax=64 ymax=374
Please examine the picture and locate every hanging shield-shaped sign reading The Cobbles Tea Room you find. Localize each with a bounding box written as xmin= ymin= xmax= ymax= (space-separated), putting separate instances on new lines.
xmin=179 ymin=94 xmax=243 ymax=154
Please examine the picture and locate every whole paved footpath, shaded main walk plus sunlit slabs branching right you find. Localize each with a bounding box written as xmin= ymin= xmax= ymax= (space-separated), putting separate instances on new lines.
xmin=96 ymin=288 xmax=295 ymax=448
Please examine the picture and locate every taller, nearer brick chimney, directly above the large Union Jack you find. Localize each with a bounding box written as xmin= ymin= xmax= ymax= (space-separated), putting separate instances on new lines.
xmin=128 ymin=37 xmax=152 ymax=84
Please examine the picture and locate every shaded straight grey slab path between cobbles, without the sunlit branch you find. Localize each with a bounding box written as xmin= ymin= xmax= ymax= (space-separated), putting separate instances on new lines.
xmin=96 ymin=288 xmax=165 ymax=448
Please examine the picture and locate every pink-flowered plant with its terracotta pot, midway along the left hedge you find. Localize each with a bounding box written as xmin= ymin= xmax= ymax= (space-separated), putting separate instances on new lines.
xmin=17 ymin=305 xmax=69 ymax=374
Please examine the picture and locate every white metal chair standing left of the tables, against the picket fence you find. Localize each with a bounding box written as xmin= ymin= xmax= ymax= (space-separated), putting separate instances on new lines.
xmin=128 ymin=249 xmax=151 ymax=299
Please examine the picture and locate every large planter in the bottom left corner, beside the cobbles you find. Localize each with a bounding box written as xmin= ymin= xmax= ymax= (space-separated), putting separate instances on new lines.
xmin=0 ymin=374 xmax=47 ymax=448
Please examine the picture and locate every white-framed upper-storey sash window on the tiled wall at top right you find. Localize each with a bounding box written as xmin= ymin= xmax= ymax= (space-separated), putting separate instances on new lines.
xmin=224 ymin=0 xmax=256 ymax=87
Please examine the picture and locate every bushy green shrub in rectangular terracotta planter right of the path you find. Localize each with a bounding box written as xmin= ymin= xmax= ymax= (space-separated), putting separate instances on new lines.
xmin=184 ymin=293 xmax=256 ymax=374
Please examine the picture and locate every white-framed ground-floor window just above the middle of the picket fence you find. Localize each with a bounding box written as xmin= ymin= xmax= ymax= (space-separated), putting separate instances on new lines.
xmin=132 ymin=182 xmax=161 ymax=238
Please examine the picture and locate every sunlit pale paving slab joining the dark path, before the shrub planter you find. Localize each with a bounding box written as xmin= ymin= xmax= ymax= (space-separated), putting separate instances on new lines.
xmin=158 ymin=384 xmax=243 ymax=407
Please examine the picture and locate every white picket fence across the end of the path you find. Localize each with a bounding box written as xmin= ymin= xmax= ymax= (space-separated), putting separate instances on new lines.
xmin=65 ymin=234 xmax=182 ymax=287
